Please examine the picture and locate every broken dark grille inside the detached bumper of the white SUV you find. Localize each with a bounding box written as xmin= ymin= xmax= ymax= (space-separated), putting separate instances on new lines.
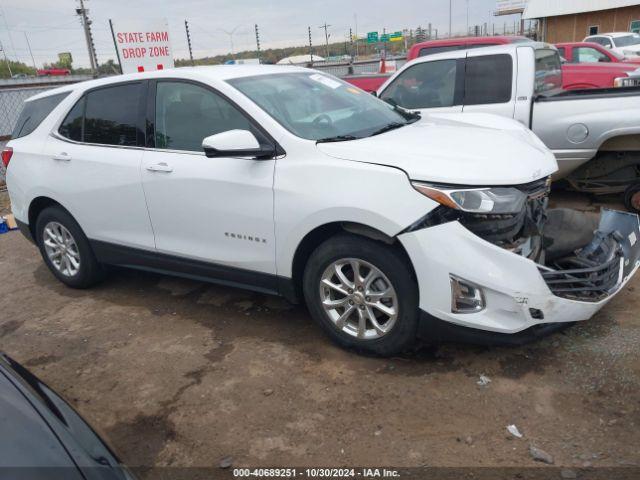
xmin=538 ymin=237 xmax=623 ymax=302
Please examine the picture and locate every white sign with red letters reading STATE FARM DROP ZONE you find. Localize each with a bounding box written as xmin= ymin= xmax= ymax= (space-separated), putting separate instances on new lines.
xmin=112 ymin=19 xmax=174 ymax=73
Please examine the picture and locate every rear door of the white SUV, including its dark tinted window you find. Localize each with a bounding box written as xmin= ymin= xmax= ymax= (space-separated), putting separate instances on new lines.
xmin=43 ymin=81 xmax=155 ymax=249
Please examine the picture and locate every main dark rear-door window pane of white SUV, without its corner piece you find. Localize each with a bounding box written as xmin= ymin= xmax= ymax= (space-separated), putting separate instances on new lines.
xmin=83 ymin=83 xmax=143 ymax=146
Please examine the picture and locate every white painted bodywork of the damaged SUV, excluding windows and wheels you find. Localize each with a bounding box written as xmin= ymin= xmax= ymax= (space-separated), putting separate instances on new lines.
xmin=7 ymin=64 xmax=626 ymax=342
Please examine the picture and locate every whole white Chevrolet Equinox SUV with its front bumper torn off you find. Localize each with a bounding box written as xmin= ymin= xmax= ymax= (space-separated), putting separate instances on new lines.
xmin=2 ymin=66 xmax=640 ymax=355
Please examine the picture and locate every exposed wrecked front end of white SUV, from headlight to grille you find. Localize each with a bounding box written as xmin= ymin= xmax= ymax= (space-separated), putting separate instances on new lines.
xmin=407 ymin=178 xmax=640 ymax=302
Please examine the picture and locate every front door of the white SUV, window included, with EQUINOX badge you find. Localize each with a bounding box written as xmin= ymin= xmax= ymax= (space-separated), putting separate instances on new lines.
xmin=142 ymin=80 xmax=275 ymax=283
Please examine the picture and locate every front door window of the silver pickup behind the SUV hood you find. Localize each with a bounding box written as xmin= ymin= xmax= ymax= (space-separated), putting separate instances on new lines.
xmin=380 ymin=60 xmax=459 ymax=108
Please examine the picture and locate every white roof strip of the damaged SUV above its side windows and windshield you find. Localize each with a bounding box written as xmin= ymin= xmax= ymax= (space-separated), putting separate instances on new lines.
xmin=27 ymin=65 xmax=310 ymax=101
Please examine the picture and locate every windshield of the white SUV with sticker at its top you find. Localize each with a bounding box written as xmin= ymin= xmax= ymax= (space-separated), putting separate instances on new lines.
xmin=228 ymin=70 xmax=411 ymax=141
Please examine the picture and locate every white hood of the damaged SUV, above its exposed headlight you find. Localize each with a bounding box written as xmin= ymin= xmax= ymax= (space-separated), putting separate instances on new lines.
xmin=318 ymin=113 xmax=558 ymax=186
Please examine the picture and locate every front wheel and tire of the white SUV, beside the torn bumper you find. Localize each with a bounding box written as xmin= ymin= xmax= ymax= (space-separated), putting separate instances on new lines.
xmin=303 ymin=234 xmax=419 ymax=356
